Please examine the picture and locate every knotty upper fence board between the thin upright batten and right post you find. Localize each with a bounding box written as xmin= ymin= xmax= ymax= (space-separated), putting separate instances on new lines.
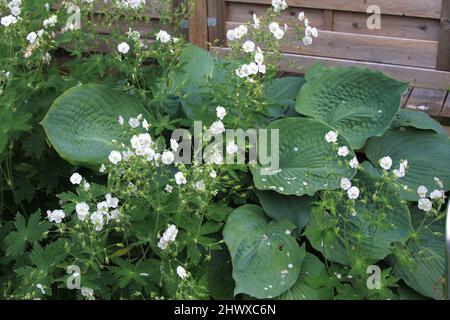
xmin=334 ymin=11 xmax=441 ymax=41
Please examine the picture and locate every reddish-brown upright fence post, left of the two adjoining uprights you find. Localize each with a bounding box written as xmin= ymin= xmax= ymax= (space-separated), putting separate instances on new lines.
xmin=189 ymin=0 xmax=208 ymax=49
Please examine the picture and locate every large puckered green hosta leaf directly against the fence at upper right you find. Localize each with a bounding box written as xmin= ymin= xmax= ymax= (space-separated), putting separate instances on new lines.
xmin=296 ymin=66 xmax=407 ymax=149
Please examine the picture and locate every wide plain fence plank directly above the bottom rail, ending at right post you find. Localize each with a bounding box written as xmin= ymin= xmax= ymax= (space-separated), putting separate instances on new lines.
xmin=227 ymin=22 xmax=438 ymax=68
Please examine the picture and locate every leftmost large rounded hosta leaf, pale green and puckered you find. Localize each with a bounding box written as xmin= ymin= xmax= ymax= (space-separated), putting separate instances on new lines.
xmin=41 ymin=84 xmax=147 ymax=167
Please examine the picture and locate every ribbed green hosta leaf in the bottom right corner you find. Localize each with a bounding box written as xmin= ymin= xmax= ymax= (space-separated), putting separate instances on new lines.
xmin=388 ymin=208 xmax=445 ymax=300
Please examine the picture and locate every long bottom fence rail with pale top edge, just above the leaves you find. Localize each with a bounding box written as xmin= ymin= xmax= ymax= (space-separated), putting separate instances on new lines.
xmin=211 ymin=47 xmax=450 ymax=90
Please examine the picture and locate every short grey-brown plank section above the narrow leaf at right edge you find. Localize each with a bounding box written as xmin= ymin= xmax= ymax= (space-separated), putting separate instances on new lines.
xmin=405 ymin=87 xmax=447 ymax=116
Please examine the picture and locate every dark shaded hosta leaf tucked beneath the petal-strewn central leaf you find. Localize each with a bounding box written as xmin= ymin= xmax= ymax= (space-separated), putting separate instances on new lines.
xmin=256 ymin=190 xmax=313 ymax=236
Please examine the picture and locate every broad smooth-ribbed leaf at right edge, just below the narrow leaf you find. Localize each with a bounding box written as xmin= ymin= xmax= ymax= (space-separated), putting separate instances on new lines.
xmin=366 ymin=128 xmax=450 ymax=201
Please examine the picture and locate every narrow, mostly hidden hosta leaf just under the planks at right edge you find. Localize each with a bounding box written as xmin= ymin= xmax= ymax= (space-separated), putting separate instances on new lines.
xmin=391 ymin=109 xmax=447 ymax=135
